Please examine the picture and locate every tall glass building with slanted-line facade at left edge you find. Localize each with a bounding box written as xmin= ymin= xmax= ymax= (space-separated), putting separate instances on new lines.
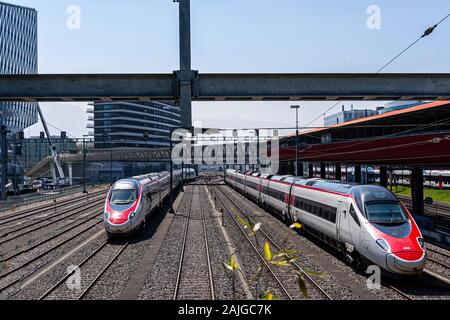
xmin=0 ymin=2 xmax=38 ymax=133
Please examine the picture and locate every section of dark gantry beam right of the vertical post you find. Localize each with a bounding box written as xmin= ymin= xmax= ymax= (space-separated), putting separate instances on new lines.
xmin=197 ymin=73 xmax=450 ymax=101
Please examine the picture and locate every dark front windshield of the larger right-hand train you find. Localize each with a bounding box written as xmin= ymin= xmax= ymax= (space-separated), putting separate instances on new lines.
xmin=366 ymin=201 xmax=408 ymax=223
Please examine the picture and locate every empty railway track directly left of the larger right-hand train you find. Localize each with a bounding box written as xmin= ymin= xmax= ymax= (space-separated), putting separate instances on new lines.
xmin=212 ymin=186 xmax=332 ymax=300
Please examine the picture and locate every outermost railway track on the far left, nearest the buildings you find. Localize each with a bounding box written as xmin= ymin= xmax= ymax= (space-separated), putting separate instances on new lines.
xmin=0 ymin=189 xmax=106 ymax=226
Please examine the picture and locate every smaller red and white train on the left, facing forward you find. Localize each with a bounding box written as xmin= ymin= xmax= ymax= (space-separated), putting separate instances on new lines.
xmin=103 ymin=168 xmax=196 ymax=235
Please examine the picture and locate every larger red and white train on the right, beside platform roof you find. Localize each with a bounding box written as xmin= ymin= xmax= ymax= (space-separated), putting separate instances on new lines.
xmin=225 ymin=170 xmax=427 ymax=275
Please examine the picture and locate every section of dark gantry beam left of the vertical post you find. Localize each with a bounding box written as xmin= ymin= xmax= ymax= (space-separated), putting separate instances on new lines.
xmin=0 ymin=74 xmax=174 ymax=101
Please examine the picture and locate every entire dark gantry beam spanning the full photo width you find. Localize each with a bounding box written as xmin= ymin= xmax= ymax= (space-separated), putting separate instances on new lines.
xmin=0 ymin=71 xmax=450 ymax=101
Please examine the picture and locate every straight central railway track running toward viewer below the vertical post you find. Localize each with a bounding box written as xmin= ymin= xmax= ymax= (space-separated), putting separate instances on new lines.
xmin=173 ymin=186 xmax=215 ymax=300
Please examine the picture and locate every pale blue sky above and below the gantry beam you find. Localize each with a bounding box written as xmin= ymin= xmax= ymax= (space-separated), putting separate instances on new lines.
xmin=9 ymin=0 xmax=450 ymax=136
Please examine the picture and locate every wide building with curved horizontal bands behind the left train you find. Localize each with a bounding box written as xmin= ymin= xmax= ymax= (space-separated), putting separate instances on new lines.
xmin=87 ymin=102 xmax=181 ymax=149
